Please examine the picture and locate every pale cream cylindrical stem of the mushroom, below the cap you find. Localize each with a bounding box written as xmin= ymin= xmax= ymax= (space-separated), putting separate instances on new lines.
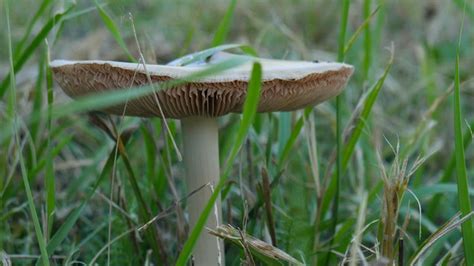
xmin=181 ymin=117 xmax=224 ymax=266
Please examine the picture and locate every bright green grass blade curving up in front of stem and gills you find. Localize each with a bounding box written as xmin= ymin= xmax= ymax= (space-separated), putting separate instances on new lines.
xmin=176 ymin=63 xmax=262 ymax=266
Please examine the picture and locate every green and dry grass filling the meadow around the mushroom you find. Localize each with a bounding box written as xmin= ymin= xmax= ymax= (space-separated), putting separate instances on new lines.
xmin=0 ymin=0 xmax=474 ymax=265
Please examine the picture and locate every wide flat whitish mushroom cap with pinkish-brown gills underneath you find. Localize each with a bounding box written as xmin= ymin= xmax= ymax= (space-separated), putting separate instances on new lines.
xmin=50 ymin=53 xmax=353 ymax=119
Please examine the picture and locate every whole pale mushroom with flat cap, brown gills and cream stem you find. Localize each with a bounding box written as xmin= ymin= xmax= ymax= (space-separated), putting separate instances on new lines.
xmin=50 ymin=52 xmax=353 ymax=265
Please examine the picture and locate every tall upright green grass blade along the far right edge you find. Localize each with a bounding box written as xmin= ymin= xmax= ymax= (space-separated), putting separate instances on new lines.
xmin=453 ymin=4 xmax=474 ymax=265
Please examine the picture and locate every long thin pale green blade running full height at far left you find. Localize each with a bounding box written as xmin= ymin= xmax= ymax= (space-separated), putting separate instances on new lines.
xmin=5 ymin=0 xmax=49 ymax=265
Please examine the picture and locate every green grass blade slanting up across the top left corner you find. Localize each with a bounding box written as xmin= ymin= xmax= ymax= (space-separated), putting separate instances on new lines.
xmin=0 ymin=2 xmax=75 ymax=99
